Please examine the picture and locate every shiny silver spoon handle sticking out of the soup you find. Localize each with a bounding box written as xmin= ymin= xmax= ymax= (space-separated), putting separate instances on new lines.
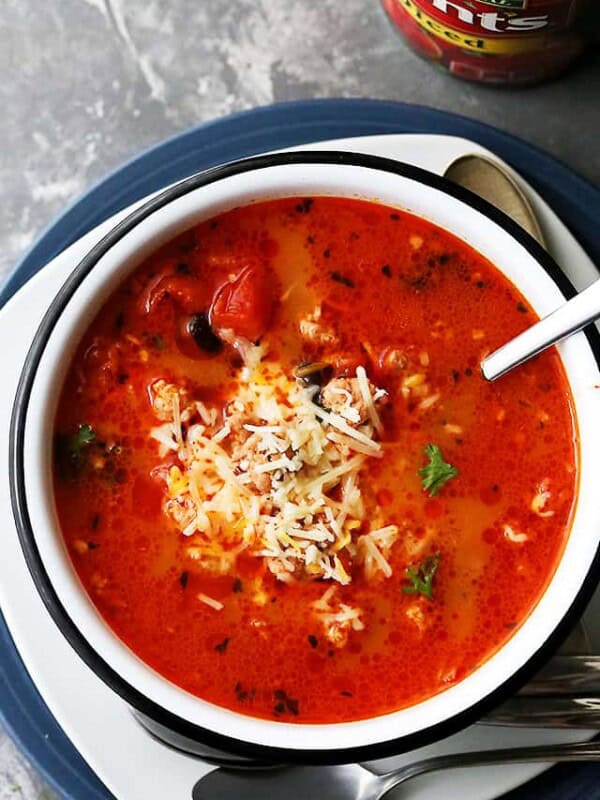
xmin=481 ymin=280 xmax=600 ymax=381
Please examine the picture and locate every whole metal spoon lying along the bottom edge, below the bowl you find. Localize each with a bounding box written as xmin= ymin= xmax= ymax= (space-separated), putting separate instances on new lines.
xmin=192 ymin=742 xmax=600 ymax=800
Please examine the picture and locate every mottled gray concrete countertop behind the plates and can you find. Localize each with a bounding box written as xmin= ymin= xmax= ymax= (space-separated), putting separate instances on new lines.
xmin=0 ymin=0 xmax=600 ymax=800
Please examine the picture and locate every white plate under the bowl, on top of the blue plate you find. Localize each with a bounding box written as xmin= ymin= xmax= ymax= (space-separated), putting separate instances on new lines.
xmin=0 ymin=135 xmax=600 ymax=800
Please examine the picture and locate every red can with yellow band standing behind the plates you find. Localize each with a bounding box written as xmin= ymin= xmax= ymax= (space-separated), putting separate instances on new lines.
xmin=382 ymin=0 xmax=588 ymax=84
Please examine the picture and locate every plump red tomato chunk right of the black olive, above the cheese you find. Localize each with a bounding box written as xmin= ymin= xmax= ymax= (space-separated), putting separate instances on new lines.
xmin=209 ymin=264 xmax=275 ymax=342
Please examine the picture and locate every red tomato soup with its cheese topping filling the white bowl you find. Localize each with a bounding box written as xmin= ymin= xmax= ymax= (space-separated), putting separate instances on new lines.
xmin=54 ymin=198 xmax=577 ymax=723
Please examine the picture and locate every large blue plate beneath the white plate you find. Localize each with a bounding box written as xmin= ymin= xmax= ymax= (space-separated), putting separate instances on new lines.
xmin=0 ymin=100 xmax=600 ymax=800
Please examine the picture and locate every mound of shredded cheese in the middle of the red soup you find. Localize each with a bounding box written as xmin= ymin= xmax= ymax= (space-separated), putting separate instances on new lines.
xmin=151 ymin=353 xmax=398 ymax=588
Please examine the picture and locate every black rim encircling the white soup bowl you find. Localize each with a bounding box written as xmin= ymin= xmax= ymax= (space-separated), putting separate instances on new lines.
xmin=9 ymin=151 xmax=600 ymax=764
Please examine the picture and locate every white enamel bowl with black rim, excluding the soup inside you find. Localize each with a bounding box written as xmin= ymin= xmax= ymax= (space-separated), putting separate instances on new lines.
xmin=11 ymin=152 xmax=600 ymax=763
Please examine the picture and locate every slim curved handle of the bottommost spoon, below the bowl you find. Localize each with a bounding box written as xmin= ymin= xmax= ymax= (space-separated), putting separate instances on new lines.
xmin=374 ymin=741 xmax=600 ymax=800
